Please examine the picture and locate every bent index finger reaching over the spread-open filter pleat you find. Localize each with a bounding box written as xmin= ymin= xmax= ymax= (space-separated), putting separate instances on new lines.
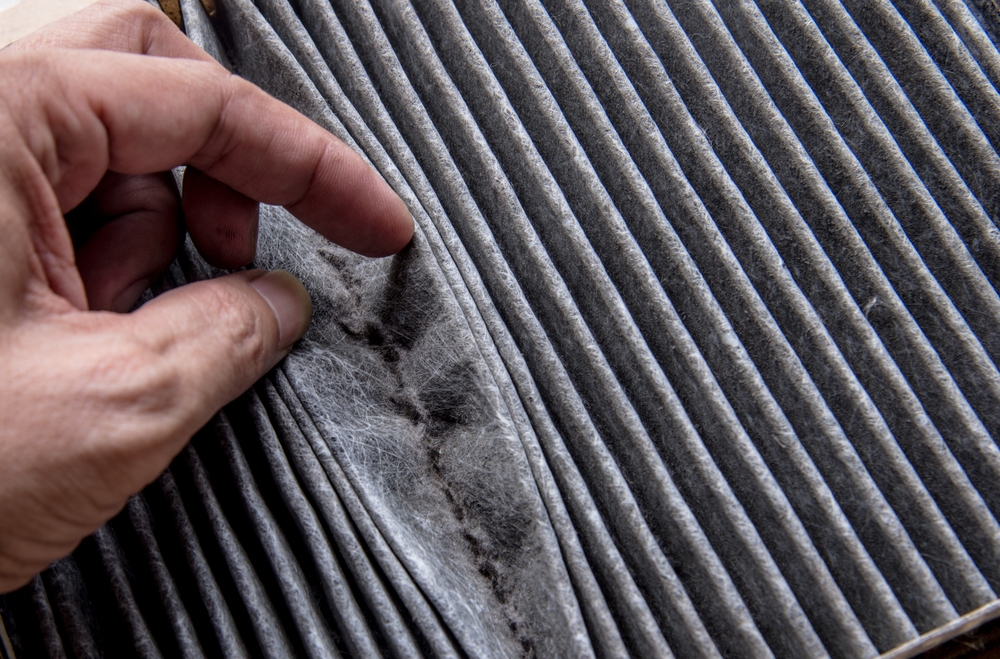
xmin=0 ymin=51 xmax=413 ymax=256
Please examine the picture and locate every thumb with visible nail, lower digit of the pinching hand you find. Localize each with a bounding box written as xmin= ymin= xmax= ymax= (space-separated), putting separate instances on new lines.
xmin=126 ymin=270 xmax=312 ymax=444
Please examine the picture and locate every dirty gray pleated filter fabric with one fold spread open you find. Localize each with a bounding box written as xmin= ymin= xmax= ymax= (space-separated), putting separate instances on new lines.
xmin=0 ymin=0 xmax=1000 ymax=659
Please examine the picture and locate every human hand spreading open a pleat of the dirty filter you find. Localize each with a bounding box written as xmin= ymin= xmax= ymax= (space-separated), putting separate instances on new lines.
xmin=0 ymin=0 xmax=413 ymax=592
